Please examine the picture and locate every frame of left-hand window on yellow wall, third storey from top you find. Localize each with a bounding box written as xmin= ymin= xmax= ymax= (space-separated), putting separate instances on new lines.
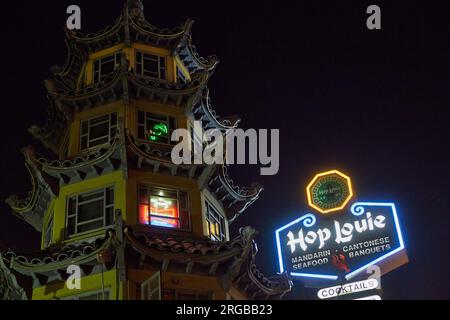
xmin=66 ymin=186 xmax=116 ymax=239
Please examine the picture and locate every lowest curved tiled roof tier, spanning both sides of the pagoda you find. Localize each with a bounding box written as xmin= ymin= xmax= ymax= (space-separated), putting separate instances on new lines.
xmin=0 ymin=226 xmax=291 ymax=299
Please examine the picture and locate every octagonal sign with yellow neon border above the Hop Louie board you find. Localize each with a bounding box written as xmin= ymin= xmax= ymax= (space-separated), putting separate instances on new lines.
xmin=306 ymin=170 xmax=353 ymax=214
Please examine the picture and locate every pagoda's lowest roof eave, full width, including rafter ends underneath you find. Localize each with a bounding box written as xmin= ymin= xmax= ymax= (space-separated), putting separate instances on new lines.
xmin=0 ymin=224 xmax=292 ymax=300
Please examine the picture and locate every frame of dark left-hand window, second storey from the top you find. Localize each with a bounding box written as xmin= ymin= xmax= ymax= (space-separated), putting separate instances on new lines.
xmin=79 ymin=112 xmax=119 ymax=151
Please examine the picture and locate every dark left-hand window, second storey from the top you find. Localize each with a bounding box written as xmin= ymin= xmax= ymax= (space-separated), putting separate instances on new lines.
xmin=80 ymin=112 xmax=117 ymax=150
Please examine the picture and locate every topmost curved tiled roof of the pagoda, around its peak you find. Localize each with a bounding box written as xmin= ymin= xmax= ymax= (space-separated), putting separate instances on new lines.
xmin=52 ymin=0 xmax=219 ymax=90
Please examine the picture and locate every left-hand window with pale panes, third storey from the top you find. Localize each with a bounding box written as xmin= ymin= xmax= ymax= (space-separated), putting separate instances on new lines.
xmin=67 ymin=188 xmax=114 ymax=236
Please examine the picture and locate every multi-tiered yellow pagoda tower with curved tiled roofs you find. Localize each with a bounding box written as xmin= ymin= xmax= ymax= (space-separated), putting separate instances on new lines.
xmin=0 ymin=0 xmax=291 ymax=300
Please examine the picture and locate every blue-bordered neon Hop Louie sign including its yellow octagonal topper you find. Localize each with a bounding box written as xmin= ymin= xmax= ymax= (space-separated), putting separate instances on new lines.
xmin=276 ymin=171 xmax=405 ymax=280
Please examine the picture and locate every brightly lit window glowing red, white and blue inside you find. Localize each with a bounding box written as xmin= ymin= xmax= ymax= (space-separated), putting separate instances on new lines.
xmin=139 ymin=187 xmax=190 ymax=230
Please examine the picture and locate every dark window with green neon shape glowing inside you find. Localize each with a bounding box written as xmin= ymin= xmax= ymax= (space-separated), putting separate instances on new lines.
xmin=138 ymin=111 xmax=176 ymax=144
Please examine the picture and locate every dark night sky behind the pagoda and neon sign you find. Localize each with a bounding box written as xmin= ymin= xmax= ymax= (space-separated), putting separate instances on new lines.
xmin=0 ymin=0 xmax=450 ymax=299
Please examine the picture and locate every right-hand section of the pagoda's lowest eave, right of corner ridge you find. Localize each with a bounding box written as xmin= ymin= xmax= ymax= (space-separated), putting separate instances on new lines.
xmin=125 ymin=227 xmax=292 ymax=299
